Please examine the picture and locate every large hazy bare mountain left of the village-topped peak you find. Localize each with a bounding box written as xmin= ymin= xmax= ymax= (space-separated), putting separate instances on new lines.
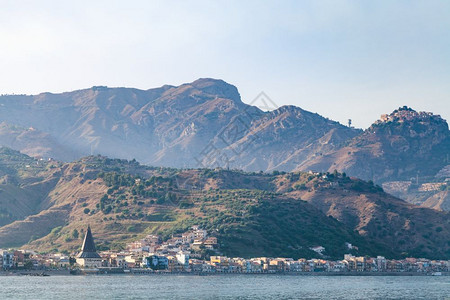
xmin=0 ymin=79 xmax=360 ymax=171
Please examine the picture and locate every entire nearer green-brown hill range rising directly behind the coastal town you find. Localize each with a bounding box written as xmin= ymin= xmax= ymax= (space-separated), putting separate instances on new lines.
xmin=0 ymin=148 xmax=450 ymax=258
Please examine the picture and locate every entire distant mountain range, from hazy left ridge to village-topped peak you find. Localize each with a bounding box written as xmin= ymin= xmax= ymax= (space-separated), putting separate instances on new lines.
xmin=0 ymin=78 xmax=450 ymax=210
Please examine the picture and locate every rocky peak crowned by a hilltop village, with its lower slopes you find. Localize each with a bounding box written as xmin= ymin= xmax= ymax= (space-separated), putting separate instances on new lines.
xmin=297 ymin=106 xmax=450 ymax=210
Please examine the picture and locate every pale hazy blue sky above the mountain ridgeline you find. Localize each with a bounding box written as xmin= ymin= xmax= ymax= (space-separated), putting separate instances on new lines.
xmin=0 ymin=0 xmax=450 ymax=128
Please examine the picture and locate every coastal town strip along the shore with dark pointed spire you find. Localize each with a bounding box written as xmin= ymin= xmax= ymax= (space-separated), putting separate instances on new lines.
xmin=0 ymin=226 xmax=450 ymax=275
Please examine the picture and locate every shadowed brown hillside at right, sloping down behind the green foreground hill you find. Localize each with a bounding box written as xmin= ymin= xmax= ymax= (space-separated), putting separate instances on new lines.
xmin=278 ymin=173 xmax=450 ymax=257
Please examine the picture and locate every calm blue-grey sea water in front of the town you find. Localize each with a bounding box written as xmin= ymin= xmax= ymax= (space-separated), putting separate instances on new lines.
xmin=0 ymin=275 xmax=450 ymax=299
